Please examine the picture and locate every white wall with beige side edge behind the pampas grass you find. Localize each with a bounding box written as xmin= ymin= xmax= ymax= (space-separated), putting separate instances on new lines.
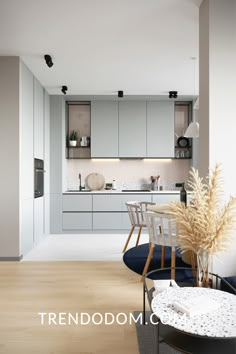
xmin=199 ymin=0 xmax=236 ymax=275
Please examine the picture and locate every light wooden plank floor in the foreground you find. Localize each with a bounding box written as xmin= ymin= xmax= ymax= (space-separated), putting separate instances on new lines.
xmin=0 ymin=261 xmax=142 ymax=354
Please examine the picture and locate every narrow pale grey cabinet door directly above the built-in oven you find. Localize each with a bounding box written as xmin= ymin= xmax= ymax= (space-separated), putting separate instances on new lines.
xmin=34 ymin=78 xmax=44 ymax=159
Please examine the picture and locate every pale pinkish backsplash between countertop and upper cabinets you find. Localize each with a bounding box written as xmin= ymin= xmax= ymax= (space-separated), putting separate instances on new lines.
xmin=64 ymin=160 xmax=191 ymax=190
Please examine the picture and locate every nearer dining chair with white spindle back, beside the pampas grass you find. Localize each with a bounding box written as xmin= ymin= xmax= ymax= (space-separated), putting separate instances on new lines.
xmin=141 ymin=211 xmax=178 ymax=280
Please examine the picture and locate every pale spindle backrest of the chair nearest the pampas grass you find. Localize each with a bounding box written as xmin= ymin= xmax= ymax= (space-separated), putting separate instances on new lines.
xmin=144 ymin=211 xmax=177 ymax=247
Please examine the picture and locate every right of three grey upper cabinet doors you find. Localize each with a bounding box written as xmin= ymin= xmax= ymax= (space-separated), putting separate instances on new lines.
xmin=147 ymin=102 xmax=174 ymax=158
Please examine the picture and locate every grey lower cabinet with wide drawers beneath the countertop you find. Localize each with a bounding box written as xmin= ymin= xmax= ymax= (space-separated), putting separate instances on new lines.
xmin=62 ymin=193 xmax=179 ymax=232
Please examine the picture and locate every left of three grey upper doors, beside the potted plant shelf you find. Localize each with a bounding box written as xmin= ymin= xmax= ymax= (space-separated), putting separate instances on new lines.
xmin=91 ymin=101 xmax=118 ymax=157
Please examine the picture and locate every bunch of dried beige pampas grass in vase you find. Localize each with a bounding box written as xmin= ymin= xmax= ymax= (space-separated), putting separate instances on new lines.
xmin=170 ymin=165 xmax=236 ymax=286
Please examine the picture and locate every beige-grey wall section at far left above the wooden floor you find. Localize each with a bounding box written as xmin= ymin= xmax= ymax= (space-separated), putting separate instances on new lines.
xmin=0 ymin=57 xmax=20 ymax=258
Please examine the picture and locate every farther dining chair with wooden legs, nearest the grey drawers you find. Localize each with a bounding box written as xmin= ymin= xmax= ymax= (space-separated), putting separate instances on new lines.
xmin=123 ymin=201 xmax=155 ymax=253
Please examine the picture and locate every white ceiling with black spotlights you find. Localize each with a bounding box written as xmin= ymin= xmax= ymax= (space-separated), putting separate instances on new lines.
xmin=0 ymin=0 xmax=202 ymax=95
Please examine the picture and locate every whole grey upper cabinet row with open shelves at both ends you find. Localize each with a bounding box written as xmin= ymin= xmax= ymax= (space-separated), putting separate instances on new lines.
xmin=67 ymin=100 xmax=191 ymax=159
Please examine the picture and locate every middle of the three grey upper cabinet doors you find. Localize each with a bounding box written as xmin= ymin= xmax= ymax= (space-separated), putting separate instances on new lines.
xmin=119 ymin=101 xmax=146 ymax=157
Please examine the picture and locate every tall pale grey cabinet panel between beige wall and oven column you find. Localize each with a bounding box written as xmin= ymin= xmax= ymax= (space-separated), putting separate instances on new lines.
xmin=20 ymin=62 xmax=34 ymax=255
